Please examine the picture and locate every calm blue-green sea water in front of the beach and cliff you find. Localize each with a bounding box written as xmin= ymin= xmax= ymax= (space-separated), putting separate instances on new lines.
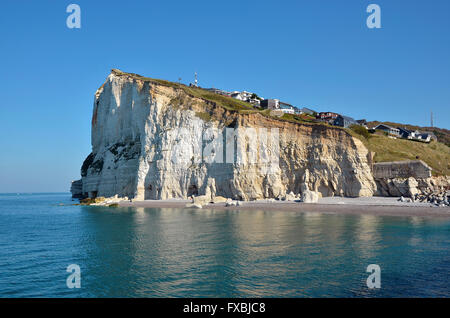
xmin=0 ymin=194 xmax=450 ymax=297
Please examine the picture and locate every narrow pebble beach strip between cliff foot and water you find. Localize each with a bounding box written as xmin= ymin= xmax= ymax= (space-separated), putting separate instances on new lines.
xmin=118 ymin=197 xmax=450 ymax=218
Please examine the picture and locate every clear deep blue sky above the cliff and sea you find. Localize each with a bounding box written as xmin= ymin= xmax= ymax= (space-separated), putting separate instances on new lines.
xmin=0 ymin=0 xmax=450 ymax=192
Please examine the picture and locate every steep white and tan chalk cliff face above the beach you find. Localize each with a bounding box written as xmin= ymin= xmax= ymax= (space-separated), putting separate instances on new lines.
xmin=74 ymin=71 xmax=376 ymax=200
